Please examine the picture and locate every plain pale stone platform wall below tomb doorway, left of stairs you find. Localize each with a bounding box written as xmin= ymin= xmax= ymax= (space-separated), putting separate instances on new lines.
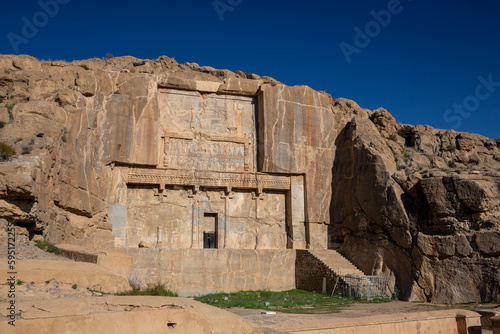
xmin=120 ymin=248 xmax=295 ymax=296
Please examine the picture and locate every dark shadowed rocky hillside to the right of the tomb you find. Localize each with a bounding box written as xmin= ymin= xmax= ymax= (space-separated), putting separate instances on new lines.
xmin=330 ymin=100 xmax=500 ymax=303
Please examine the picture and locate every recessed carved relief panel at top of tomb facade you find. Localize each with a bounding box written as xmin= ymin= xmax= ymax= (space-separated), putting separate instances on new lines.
xmin=158 ymin=89 xmax=256 ymax=172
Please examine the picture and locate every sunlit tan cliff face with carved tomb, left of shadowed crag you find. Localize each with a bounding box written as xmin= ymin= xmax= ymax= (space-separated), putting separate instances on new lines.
xmin=0 ymin=56 xmax=333 ymax=249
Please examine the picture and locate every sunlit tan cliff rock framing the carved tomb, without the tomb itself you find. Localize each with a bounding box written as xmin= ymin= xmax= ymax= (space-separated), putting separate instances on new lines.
xmin=0 ymin=55 xmax=335 ymax=247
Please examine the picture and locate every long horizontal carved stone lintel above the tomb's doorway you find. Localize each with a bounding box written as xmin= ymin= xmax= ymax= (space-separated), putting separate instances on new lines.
xmin=127 ymin=168 xmax=290 ymax=190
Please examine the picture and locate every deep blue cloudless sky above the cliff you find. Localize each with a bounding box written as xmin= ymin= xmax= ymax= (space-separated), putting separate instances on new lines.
xmin=0 ymin=0 xmax=500 ymax=138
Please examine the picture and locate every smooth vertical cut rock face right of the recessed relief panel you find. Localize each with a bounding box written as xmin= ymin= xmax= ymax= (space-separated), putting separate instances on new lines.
xmin=258 ymin=85 xmax=335 ymax=223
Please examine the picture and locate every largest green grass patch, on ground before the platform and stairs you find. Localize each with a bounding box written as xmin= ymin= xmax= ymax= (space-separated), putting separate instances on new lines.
xmin=195 ymin=289 xmax=389 ymax=313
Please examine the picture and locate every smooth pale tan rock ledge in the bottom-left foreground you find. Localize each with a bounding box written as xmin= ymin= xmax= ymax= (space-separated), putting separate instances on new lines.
xmin=0 ymin=296 xmax=263 ymax=334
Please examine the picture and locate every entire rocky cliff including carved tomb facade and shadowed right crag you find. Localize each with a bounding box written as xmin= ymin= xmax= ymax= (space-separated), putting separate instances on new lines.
xmin=0 ymin=55 xmax=500 ymax=302
